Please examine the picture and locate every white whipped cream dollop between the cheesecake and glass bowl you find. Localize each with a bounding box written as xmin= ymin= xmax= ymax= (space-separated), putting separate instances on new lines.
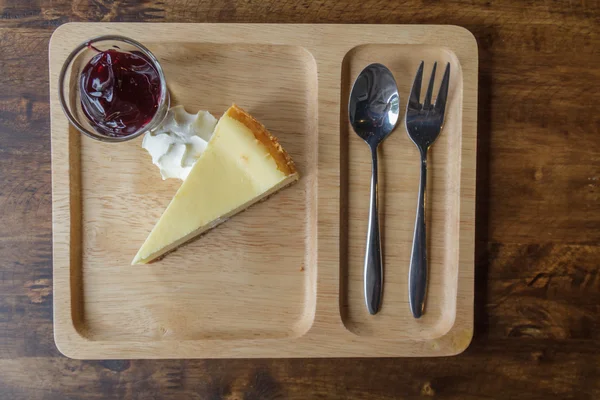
xmin=142 ymin=106 xmax=217 ymax=180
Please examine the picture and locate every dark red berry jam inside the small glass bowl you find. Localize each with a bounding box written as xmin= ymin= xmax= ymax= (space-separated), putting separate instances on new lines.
xmin=80 ymin=48 xmax=161 ymax=137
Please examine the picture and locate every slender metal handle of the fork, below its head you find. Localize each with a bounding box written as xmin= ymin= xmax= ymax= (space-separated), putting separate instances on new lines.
xmin=408 ymin=150 xmax=427 ymax=318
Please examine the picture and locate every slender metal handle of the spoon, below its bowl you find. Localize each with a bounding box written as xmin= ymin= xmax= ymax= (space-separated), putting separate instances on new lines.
xmin=365 ymin=145 xmax=383 ymax=314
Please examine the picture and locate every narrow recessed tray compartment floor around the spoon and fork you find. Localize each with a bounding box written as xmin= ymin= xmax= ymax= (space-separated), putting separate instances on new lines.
xmin=340 ymin=44 xmax=463 ymax=339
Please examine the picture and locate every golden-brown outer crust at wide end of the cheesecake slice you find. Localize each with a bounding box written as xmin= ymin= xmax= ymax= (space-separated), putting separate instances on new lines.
xmin=225 ymin=104 xmax=298 ymax=176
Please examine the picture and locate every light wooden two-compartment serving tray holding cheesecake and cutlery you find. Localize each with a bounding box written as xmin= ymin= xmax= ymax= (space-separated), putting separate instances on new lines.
xmin=50 ymin=23 xmax=478 ymax=359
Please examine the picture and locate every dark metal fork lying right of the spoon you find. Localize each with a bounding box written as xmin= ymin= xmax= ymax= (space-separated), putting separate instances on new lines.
xmin=406 ymin=61 xmax=450 ymax=318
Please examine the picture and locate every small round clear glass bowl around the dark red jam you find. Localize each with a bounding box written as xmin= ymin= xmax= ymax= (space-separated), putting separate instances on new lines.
xmin=58 ymin=35 xmax=170 ymax=142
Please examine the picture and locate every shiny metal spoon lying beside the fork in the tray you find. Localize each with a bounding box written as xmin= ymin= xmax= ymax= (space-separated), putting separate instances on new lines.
xmin=348 ymin=64 xmax=400 ymax=314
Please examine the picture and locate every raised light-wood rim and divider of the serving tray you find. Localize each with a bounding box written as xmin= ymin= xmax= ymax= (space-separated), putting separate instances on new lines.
xmin=49 ymin=22 xmax=478 ymax=359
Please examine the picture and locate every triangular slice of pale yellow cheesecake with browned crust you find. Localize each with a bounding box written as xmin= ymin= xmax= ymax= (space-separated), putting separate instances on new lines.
xmin=132 ymin=104 xmax=298 ymax=264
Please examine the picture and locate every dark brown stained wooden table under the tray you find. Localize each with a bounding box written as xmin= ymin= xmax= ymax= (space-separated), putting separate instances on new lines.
xmin=0 ymin=0 xmax=600 ymax=400
